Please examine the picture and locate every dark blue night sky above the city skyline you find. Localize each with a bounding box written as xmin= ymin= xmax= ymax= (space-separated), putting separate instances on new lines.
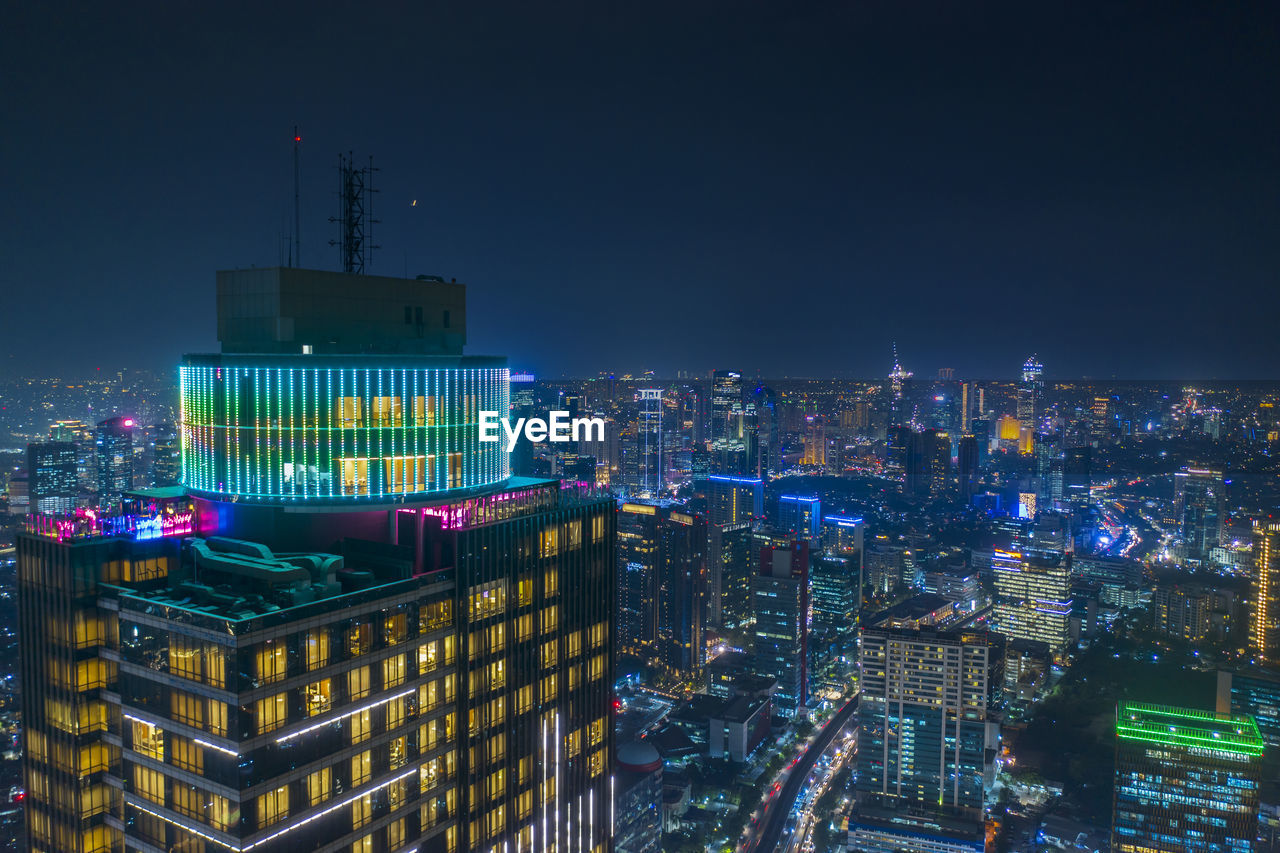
xmin=0 ymin=1 xmax=1280 ymax=378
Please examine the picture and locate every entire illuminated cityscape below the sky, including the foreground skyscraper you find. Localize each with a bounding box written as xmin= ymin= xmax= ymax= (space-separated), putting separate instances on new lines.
xmin=0 ymin=274 xmax=1280 ymax=853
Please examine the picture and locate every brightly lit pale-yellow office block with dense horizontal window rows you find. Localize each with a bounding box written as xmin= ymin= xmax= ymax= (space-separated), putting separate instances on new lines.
xmin=991 ymin=549 xmax=1071 ymax=654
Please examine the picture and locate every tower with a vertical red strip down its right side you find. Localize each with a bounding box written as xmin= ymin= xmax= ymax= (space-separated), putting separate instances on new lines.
xmin=751 ymin=539 xmax=809 ymax=715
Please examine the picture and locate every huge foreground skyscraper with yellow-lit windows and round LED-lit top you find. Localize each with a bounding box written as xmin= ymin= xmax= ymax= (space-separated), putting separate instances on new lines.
xmin=18 ymin=269 xmax=616 ymax=853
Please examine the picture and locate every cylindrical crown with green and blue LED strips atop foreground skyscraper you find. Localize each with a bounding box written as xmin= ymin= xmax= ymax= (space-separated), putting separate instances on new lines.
xmin=179 ymin=355 xmax=511 ymax=503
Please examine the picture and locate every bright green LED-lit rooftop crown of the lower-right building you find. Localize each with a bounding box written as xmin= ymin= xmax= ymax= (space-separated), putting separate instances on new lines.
xmin=1116 ymin=702 xmax=1265 ymax=757
